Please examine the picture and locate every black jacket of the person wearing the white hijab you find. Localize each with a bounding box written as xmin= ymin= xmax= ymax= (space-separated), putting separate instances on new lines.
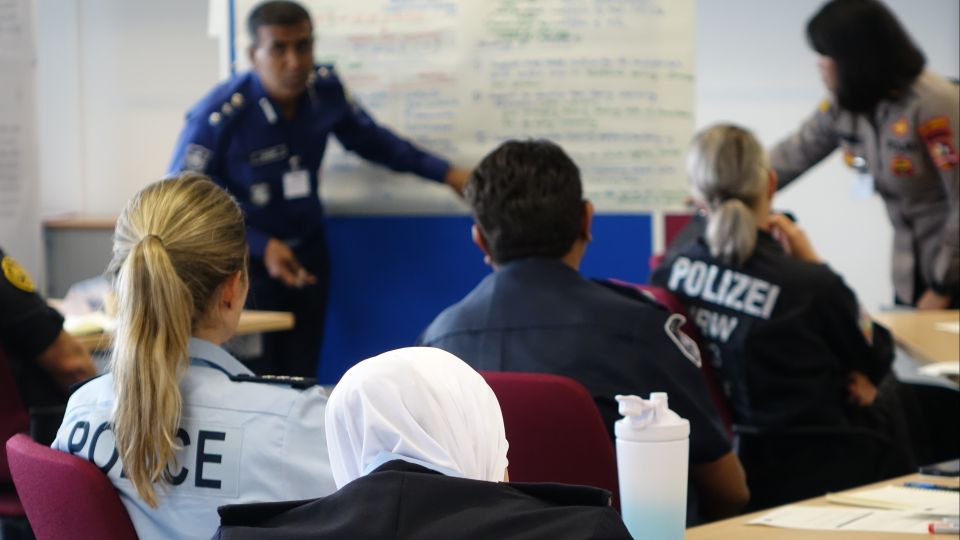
xmin=215 ymin=460 xmax=630 ymax=540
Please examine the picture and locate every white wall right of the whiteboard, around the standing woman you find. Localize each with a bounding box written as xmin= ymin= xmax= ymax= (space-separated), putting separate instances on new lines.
xmin=697 ymin=0 xmax=960 ymax=309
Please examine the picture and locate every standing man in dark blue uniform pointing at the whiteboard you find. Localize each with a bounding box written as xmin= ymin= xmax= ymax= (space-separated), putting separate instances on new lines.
xmin=170 ymin=1 xmax=469 ymax=377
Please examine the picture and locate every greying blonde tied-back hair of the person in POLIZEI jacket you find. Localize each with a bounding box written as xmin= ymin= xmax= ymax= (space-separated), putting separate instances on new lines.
xmin=687 ymin=125 xmax=770 ymax=265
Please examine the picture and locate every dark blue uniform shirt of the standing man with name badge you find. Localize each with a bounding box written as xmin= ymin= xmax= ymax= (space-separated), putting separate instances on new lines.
xmin=169 ymin=65 xmax=450 ymax=257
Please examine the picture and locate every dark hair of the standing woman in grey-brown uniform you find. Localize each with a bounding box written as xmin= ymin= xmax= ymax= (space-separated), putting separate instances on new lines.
xmin=807 ymin=0 xmax=926 ymax=113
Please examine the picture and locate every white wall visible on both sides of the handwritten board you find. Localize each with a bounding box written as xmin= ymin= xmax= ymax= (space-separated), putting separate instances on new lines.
xmin=35 ymin=0 xmax=960 ymax=308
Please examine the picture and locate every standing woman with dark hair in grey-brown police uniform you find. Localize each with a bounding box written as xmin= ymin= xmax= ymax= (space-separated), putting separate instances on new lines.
xmin=770 ymin=0 xmax=960 ymax=309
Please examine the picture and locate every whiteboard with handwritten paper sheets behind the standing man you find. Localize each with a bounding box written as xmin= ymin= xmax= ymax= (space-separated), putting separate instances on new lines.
xmin=233 ymin=0 xmax=695 ymax=214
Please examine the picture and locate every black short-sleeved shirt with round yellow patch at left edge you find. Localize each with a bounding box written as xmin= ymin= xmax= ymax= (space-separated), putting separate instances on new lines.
xmin=0 ymin=249 xmax=67 ymax=407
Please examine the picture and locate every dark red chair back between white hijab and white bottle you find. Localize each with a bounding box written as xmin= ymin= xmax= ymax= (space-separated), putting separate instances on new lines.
xmin=480 ymin=371 xmax=620 ymax=510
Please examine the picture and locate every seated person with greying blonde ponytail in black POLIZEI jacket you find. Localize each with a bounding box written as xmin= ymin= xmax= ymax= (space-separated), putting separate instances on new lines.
xmin=651 ymin=125 xmax=913 ymax=506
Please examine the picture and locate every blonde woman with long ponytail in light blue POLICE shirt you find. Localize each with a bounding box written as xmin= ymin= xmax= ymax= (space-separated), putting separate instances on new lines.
xmin=53 ymin=173 xmax=334 ymax=538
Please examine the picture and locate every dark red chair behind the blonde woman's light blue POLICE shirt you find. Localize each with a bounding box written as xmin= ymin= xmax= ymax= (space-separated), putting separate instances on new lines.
xmin=7 ymin=433 xmax=137 ymax=540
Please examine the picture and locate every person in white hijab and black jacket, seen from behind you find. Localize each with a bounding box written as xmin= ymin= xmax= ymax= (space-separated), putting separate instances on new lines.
xmin=219 ymin=347 xmax=630 ymax=540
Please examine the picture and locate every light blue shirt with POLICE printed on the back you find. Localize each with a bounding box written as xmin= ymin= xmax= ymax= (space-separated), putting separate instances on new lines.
xmin=52 ymin=338 xmax=336 ymax=539
